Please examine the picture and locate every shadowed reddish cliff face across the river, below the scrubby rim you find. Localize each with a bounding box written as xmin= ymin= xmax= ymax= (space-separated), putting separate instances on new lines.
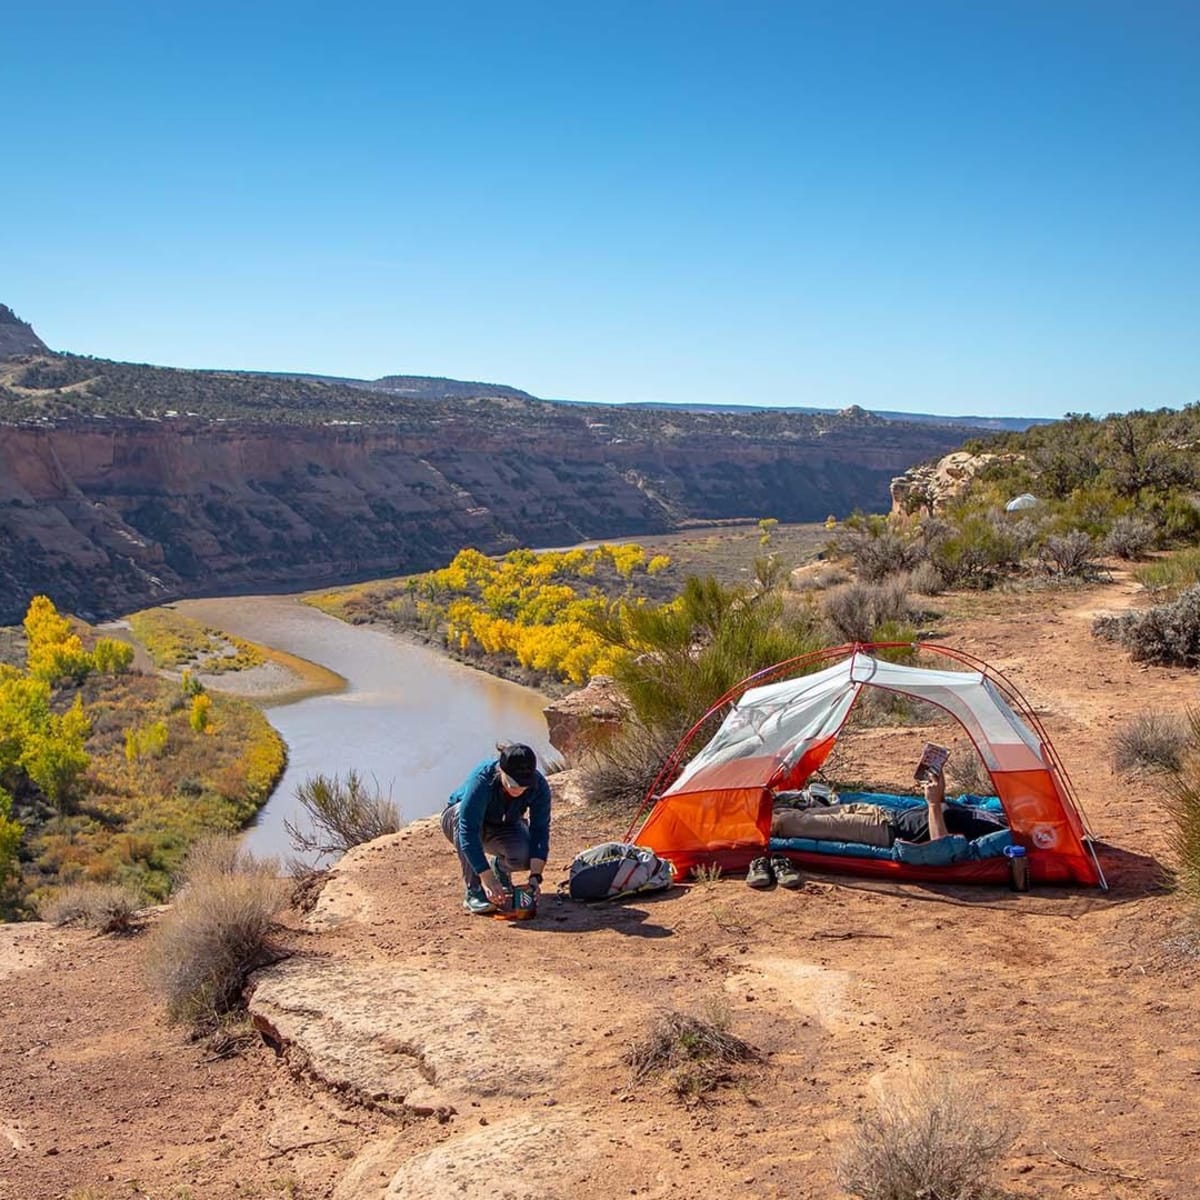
xmin=0 ymin=406 xmax=961 ymax=623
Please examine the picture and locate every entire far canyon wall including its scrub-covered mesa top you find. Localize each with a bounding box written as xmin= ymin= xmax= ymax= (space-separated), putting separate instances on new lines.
xmin=0 ymin=310 xmax=977 ymax=623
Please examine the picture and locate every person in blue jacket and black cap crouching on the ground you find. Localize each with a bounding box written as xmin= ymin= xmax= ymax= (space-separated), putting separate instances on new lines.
xmin=442 ymin=743 xmax=550 ymax=916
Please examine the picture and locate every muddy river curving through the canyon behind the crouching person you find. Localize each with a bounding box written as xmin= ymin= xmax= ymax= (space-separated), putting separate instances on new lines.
xmin=176 ymin=595 xmax=553 ymax=858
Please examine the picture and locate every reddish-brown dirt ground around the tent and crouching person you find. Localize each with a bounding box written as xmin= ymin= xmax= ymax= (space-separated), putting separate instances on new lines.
xmin=0 ymin=573 xmax=1200 ymax=1200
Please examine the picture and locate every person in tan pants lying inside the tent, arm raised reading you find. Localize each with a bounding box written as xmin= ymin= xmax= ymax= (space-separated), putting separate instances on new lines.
xmin=770 ymin=772 xmax=1008 ymax=847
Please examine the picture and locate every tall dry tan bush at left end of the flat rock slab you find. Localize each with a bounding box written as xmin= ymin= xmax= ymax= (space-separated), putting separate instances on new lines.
xmin=146 ymin=839 xmax=288 ymax=1033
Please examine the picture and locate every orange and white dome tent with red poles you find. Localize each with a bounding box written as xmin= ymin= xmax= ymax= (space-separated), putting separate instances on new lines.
xmin=626 ymin=642 xmax=1106 ymax=887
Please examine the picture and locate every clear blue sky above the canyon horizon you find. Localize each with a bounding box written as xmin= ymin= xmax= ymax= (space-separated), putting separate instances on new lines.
xmin=0 ymin=0 xmax=1200 ymax=416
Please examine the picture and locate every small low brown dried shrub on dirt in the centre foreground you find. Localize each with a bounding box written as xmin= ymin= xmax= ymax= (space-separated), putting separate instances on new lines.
xmin=624 ymin=1003 xmax=758 ymax=1099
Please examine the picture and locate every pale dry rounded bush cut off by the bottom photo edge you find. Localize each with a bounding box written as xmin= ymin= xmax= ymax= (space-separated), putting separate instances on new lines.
xmin=838 ymin=1073 xmax=1016 ymax=1200
